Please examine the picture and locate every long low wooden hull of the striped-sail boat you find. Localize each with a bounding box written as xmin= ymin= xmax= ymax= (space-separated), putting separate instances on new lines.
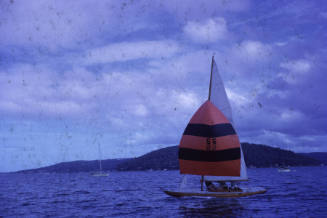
xmin=164 ymin=187 xmax=267 ymax=198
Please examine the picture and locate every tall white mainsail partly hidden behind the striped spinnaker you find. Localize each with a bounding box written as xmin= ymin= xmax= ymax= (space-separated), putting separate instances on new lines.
xmin=205 ymin=57 xmax=248 ymax=181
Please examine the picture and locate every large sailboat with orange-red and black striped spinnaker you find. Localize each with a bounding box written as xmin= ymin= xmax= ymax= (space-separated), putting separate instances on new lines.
xmin=164 ymin=56 xmax=266 ymax=197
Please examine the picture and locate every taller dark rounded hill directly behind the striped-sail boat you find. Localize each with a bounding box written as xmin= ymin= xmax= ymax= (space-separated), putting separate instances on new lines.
xmin=117 ymin=143 xmax=327 ymax=170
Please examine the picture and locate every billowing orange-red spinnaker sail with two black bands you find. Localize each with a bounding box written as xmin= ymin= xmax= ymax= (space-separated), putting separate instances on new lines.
xmin=178 ymin=100 xmax=241 ymax=176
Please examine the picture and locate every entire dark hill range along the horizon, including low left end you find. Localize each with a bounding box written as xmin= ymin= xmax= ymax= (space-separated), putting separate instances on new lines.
xmin=20 ymin=143 xmax=327 ymax=173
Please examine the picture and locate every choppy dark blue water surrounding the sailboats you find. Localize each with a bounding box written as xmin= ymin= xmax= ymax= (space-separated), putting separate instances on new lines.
xmin=0 ymin=167 xmax=327 ymax=217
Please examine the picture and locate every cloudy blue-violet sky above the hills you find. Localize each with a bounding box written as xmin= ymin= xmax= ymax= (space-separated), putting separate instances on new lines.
xmin=0 ymin=0 xmax=327 ymax=172
